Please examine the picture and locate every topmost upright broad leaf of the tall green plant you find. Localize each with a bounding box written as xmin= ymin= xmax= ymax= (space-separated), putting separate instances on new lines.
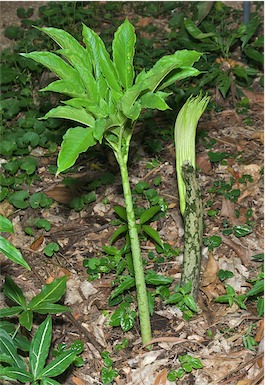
xmin=112 ymin=18 xmax=136 ymax=90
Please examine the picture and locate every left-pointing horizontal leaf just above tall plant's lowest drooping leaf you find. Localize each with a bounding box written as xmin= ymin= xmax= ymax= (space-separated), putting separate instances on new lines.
xmin=41 ymin=106 xmax=95 ymax=129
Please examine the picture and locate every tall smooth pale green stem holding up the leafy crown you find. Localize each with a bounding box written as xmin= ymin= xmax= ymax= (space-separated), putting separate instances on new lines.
xmin=115 ymin=152 xmax=152 ymax=344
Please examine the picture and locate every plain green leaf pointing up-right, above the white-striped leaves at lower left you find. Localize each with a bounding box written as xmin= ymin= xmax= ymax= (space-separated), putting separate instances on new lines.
xmin=28 ymin=276 xmax=67 ymax=310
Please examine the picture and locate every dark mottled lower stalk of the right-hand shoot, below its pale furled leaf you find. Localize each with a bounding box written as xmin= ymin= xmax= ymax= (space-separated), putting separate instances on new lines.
xmin=181 ymin=161 xmax=203 ymax=298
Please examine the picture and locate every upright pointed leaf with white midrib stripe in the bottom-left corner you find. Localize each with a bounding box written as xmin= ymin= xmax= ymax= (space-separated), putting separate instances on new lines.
xmin=29 ymin=316 xmax=52 ymax=379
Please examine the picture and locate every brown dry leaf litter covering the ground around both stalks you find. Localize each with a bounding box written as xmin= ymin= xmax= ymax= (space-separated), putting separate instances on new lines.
xmin=0 ymin=2 xmax=264 ymax=385
